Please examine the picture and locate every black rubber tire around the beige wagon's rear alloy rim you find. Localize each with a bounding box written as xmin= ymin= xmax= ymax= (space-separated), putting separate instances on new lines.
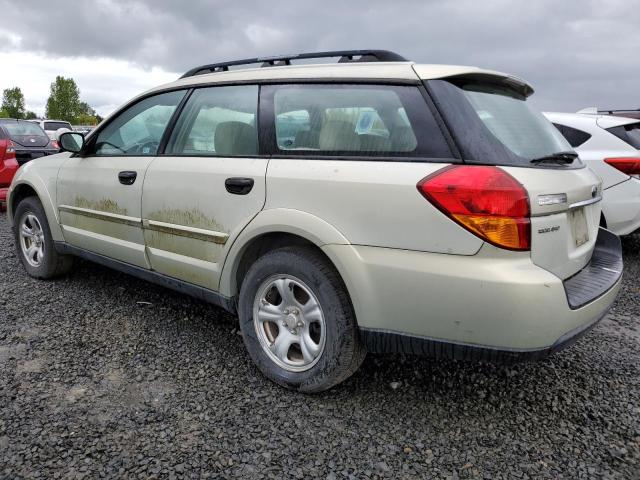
xmin=238 ymin=247 xmax=366 ymax=393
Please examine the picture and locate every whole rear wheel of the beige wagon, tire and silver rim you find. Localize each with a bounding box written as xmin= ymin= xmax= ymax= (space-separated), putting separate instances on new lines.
xmin=238 ymin=247 xmax=366 ymax=392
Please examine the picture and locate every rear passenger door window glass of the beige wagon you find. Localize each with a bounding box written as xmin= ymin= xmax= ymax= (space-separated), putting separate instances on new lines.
xmin=166 ymin=85 xmax=258 ymax=156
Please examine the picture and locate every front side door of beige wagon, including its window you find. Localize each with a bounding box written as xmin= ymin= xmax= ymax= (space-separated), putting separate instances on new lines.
xmin=57 ymin=91 xmax=185 ymax=268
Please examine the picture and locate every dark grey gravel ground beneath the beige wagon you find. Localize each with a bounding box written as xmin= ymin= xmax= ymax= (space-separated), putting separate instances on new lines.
xmin=0 ymin=214 xmax=640 ymax=479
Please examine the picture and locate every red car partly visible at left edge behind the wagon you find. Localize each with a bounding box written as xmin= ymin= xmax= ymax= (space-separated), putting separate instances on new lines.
xmin=0 ymin=118 xmax=59 ymax=210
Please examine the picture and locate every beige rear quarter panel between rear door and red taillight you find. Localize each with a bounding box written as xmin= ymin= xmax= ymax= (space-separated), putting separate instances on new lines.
xmin=265 ymin=158 xmax=483 ymax=255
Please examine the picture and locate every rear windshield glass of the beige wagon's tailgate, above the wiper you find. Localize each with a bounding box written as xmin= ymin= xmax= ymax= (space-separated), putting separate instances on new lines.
xmin=462 ymin=84 xmax=571 ymax=160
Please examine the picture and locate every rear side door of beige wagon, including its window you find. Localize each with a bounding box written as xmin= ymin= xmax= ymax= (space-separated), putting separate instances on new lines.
xmin=142 ymin=85 xmax=268 ymax=290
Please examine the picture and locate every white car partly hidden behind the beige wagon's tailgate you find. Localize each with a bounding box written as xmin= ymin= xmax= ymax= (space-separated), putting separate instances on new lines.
xmin=545 ymin=109 xmax=640 ymax=235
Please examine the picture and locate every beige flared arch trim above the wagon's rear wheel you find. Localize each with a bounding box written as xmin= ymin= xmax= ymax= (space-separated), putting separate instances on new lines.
xmin=219 ymin=208 xmax=350 ymax=297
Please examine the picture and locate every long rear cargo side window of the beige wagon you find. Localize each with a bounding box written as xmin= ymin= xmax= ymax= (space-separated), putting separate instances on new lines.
xmin=263 ymin=84 xmax=451 ymax=158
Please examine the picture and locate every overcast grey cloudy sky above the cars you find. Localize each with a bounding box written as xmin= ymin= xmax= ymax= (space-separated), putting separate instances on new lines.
xmin=0 ymin=0 xmax=640 ymax=115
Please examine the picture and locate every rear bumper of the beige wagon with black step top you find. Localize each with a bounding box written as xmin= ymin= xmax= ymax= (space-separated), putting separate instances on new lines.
xmin=324 ymin=230 xmax=622 ymax=362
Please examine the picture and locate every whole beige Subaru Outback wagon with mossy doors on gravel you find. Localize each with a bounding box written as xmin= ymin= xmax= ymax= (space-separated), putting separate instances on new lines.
xmin=8 ymin=50 xmax=622 ymax=392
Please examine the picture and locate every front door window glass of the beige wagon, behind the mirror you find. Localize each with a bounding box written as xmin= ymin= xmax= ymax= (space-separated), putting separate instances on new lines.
xmin=93 ymin=90 xmax=185 ymax=156
